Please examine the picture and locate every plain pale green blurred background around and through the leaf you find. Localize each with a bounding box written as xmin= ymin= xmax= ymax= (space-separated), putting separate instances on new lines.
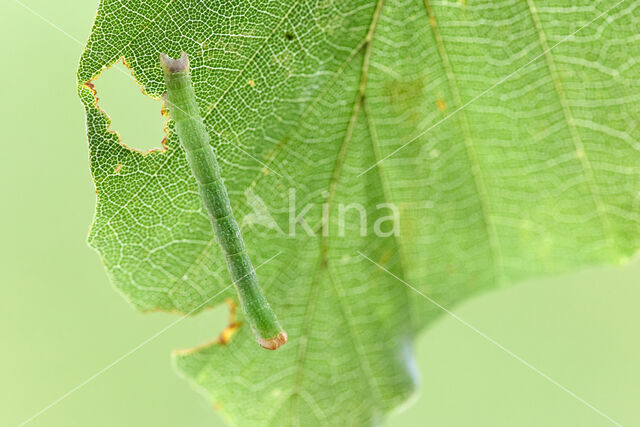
xmin=0 ymin=0 xmax=640 ymax=426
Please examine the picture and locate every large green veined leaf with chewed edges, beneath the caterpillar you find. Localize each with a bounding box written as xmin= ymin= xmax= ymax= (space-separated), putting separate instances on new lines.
xmin=78 ymin=0 xmax=640 ymax=425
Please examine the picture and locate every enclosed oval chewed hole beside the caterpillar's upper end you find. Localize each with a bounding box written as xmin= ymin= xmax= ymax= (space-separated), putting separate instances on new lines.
xmin=92 ymin=62 xmax=167 ymax=152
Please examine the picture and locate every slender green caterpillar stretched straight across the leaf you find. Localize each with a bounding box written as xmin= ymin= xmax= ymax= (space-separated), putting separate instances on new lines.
xmin=160 ymin=52 xmax=287 ymax=350
